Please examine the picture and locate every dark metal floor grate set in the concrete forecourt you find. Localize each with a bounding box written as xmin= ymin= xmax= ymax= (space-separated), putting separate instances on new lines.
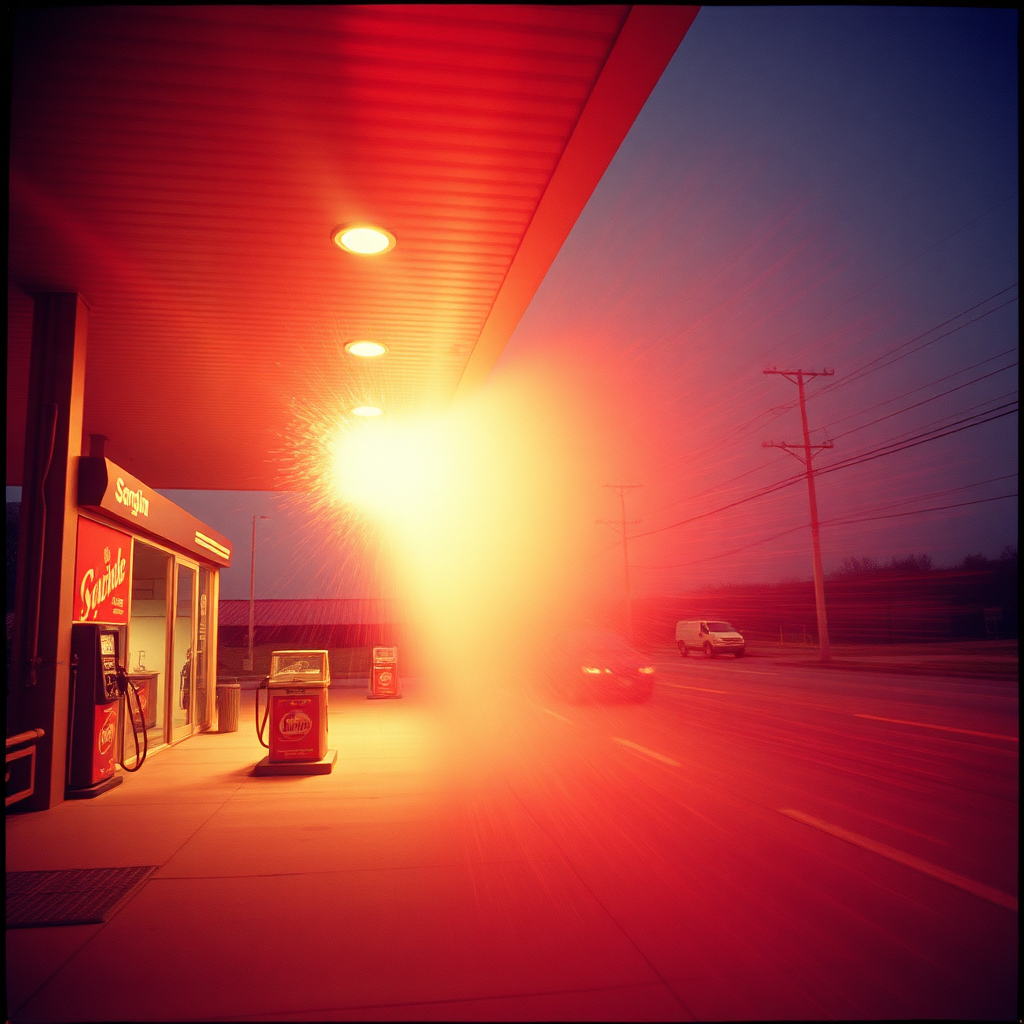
xmin=6 ymin=866 xmax=157 ymax=928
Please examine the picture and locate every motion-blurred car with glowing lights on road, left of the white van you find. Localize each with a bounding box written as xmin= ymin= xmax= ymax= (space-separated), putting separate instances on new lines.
xmin=546 ymin=630 xmax=654 ymax=702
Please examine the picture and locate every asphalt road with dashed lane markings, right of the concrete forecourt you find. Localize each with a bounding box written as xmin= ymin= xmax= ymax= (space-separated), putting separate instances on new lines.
xmin=481 ymin=655 xmax=1019 ymax=1020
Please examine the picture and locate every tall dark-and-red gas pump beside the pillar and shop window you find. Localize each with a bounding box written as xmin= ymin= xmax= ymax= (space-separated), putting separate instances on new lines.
xmin=65 ymin=623 xmax=124 ymax=800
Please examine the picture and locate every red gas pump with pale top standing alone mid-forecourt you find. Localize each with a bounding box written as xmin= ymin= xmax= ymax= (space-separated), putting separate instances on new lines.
xmin=253 ymin=650 xmax=338 ymax=775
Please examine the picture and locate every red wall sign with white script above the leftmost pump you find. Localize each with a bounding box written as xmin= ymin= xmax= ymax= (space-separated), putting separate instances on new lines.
xmin=74 ymin=516 xmax=131 ymax=626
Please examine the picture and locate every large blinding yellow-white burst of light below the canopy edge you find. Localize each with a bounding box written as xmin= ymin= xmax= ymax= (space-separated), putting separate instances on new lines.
xmin=278 ymin=344 xmax=671 ymax=715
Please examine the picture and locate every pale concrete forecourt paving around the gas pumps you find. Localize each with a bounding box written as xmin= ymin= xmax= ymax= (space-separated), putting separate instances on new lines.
xmin=7 ymin=685 xmax=686 ymax=1024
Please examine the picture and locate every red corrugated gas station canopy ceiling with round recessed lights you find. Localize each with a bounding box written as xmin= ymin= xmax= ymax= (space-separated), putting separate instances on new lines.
xmin=7 ymin=5 xmax=696 ymax=489
